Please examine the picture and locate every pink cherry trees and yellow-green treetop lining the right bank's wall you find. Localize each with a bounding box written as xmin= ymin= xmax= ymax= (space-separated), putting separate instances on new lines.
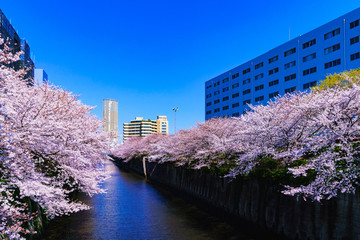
xmin=112 ymin=70 xmax=360 ymax=201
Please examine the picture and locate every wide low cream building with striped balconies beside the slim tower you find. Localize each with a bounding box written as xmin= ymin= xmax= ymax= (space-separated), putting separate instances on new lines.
xmin=123 ymin=116 xmax=169 ymax=141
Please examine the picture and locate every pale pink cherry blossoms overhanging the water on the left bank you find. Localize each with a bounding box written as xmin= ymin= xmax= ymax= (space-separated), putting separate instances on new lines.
xmin=0 ymin=40 xmax=110 ymax=239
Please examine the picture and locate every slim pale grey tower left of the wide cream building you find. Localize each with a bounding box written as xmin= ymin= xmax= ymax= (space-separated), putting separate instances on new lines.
xmin=103 ymin=99 xmax=118 ymax=140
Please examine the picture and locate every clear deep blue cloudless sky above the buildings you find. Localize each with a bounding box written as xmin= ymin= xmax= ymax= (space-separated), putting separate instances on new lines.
xmin=0 ymin=0 xmax=360 ymax=134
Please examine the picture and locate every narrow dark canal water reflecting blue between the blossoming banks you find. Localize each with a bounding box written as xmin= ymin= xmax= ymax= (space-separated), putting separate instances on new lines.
xmin=43 ymin=162 xmax=262 ymax=240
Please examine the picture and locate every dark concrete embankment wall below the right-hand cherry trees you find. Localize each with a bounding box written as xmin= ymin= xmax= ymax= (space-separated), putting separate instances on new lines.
xmin=116 ymin=159 xmax=360 ymax=240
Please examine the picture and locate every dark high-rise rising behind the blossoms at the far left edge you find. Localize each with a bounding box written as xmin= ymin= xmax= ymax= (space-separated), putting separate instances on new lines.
xmin=0 ymin=9 xmax=35 ymax=85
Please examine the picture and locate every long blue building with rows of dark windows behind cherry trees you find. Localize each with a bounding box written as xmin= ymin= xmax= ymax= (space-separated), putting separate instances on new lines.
xmin=205 ymin=8 xmax=360 ymax=120
